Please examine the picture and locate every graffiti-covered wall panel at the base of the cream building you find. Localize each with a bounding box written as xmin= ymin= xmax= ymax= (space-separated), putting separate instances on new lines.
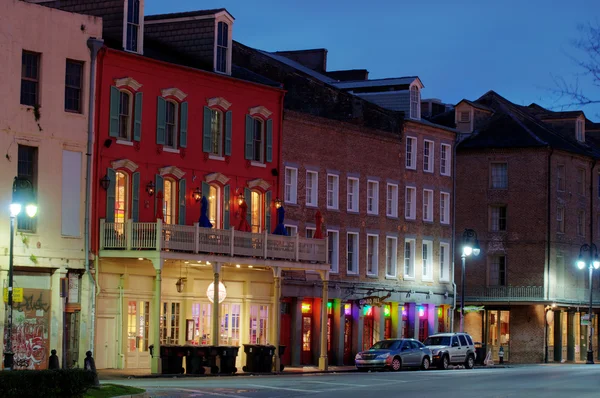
xmin=4 ymin=288 xmax=51 ymax=370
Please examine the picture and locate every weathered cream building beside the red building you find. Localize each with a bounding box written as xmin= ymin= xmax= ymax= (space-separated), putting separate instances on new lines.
xmin=0 ymin=0 xmax=102 ymax=369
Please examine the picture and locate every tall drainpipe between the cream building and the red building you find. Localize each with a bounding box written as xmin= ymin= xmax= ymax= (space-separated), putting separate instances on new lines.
xmin=84 ymin=37 xmax=104 ymax=355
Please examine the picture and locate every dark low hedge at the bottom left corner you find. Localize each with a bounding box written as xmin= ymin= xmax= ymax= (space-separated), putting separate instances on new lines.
xmin=0 ymin=369 xmax=95 ymax=398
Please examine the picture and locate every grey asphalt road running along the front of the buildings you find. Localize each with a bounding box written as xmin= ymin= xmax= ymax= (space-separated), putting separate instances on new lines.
xmin=107 ymin=364 xmax=600 ymax=398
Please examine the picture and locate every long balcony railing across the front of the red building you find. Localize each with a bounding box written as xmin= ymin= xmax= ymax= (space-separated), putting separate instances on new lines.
xmin=100 ymin=219 xmax=328 ymax=263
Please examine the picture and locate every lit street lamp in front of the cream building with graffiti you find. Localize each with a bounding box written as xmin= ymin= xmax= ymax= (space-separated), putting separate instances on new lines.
xmin=4 ymin=177 xmax=37 ymax=370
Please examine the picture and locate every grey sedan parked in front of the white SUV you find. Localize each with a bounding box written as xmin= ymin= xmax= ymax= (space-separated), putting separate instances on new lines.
xmin=354 ymin=339 xmax=431 ymax=372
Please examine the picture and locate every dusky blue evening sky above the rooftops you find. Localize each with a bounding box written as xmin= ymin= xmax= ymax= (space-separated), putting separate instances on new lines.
xmin=145 ymin=0 xmax=600 ymax=122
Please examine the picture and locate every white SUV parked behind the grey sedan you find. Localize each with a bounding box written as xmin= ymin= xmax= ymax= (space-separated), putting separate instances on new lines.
xmin=423 ymin=333 xmax=477 ymax=369
